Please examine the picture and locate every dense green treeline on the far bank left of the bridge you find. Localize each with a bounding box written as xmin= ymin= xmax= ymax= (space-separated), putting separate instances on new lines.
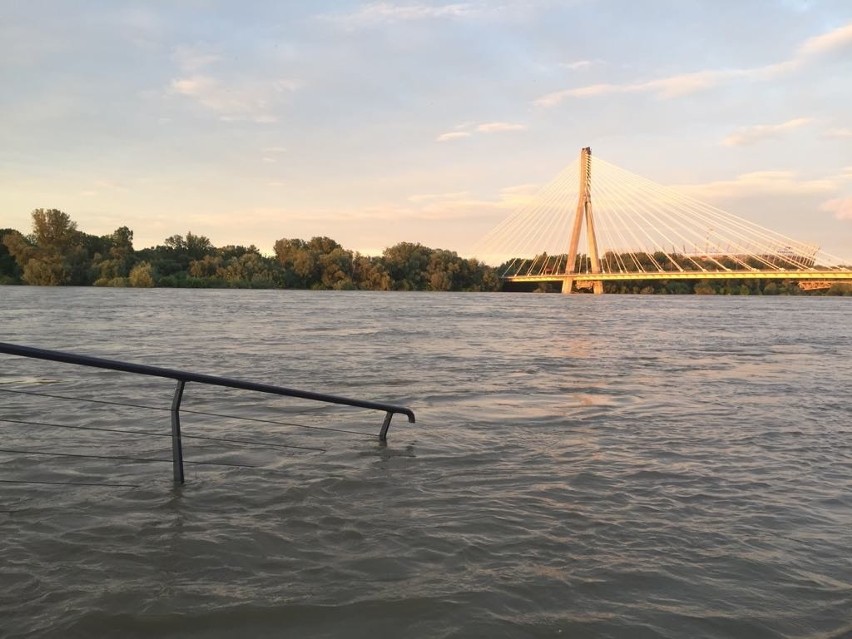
xmin=0 ymin=209 xmax=500 ymax=291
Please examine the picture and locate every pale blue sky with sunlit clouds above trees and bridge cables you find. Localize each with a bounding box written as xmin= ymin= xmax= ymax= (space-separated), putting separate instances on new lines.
xmin=0 ymin=0 xmax=852 ymax=257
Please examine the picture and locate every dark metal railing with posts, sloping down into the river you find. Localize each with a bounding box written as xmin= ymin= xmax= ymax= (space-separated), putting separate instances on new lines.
xmin=0 ymin=342 xmax=414 ymax=484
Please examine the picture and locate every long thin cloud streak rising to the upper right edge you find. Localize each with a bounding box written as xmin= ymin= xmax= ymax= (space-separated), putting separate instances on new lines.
xmin=533 ymin=23 xmax=852 ymax=108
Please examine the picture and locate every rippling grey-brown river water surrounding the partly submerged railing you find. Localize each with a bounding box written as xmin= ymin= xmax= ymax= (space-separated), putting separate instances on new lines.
xmin=0 ymin=287 xmax=852 ymax=638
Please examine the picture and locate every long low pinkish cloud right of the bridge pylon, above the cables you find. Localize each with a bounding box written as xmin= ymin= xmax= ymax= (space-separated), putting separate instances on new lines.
xmin=675 ymin=171 xmax=838 ymax=199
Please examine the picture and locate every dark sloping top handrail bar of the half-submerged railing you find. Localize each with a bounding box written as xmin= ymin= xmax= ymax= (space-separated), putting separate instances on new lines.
xmin=0 ymin=342 xmax=414 ymax=424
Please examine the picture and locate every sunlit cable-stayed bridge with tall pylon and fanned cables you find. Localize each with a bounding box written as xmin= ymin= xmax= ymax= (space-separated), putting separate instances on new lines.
xmin=477 ymin=148 xmax=852 ymax=294
